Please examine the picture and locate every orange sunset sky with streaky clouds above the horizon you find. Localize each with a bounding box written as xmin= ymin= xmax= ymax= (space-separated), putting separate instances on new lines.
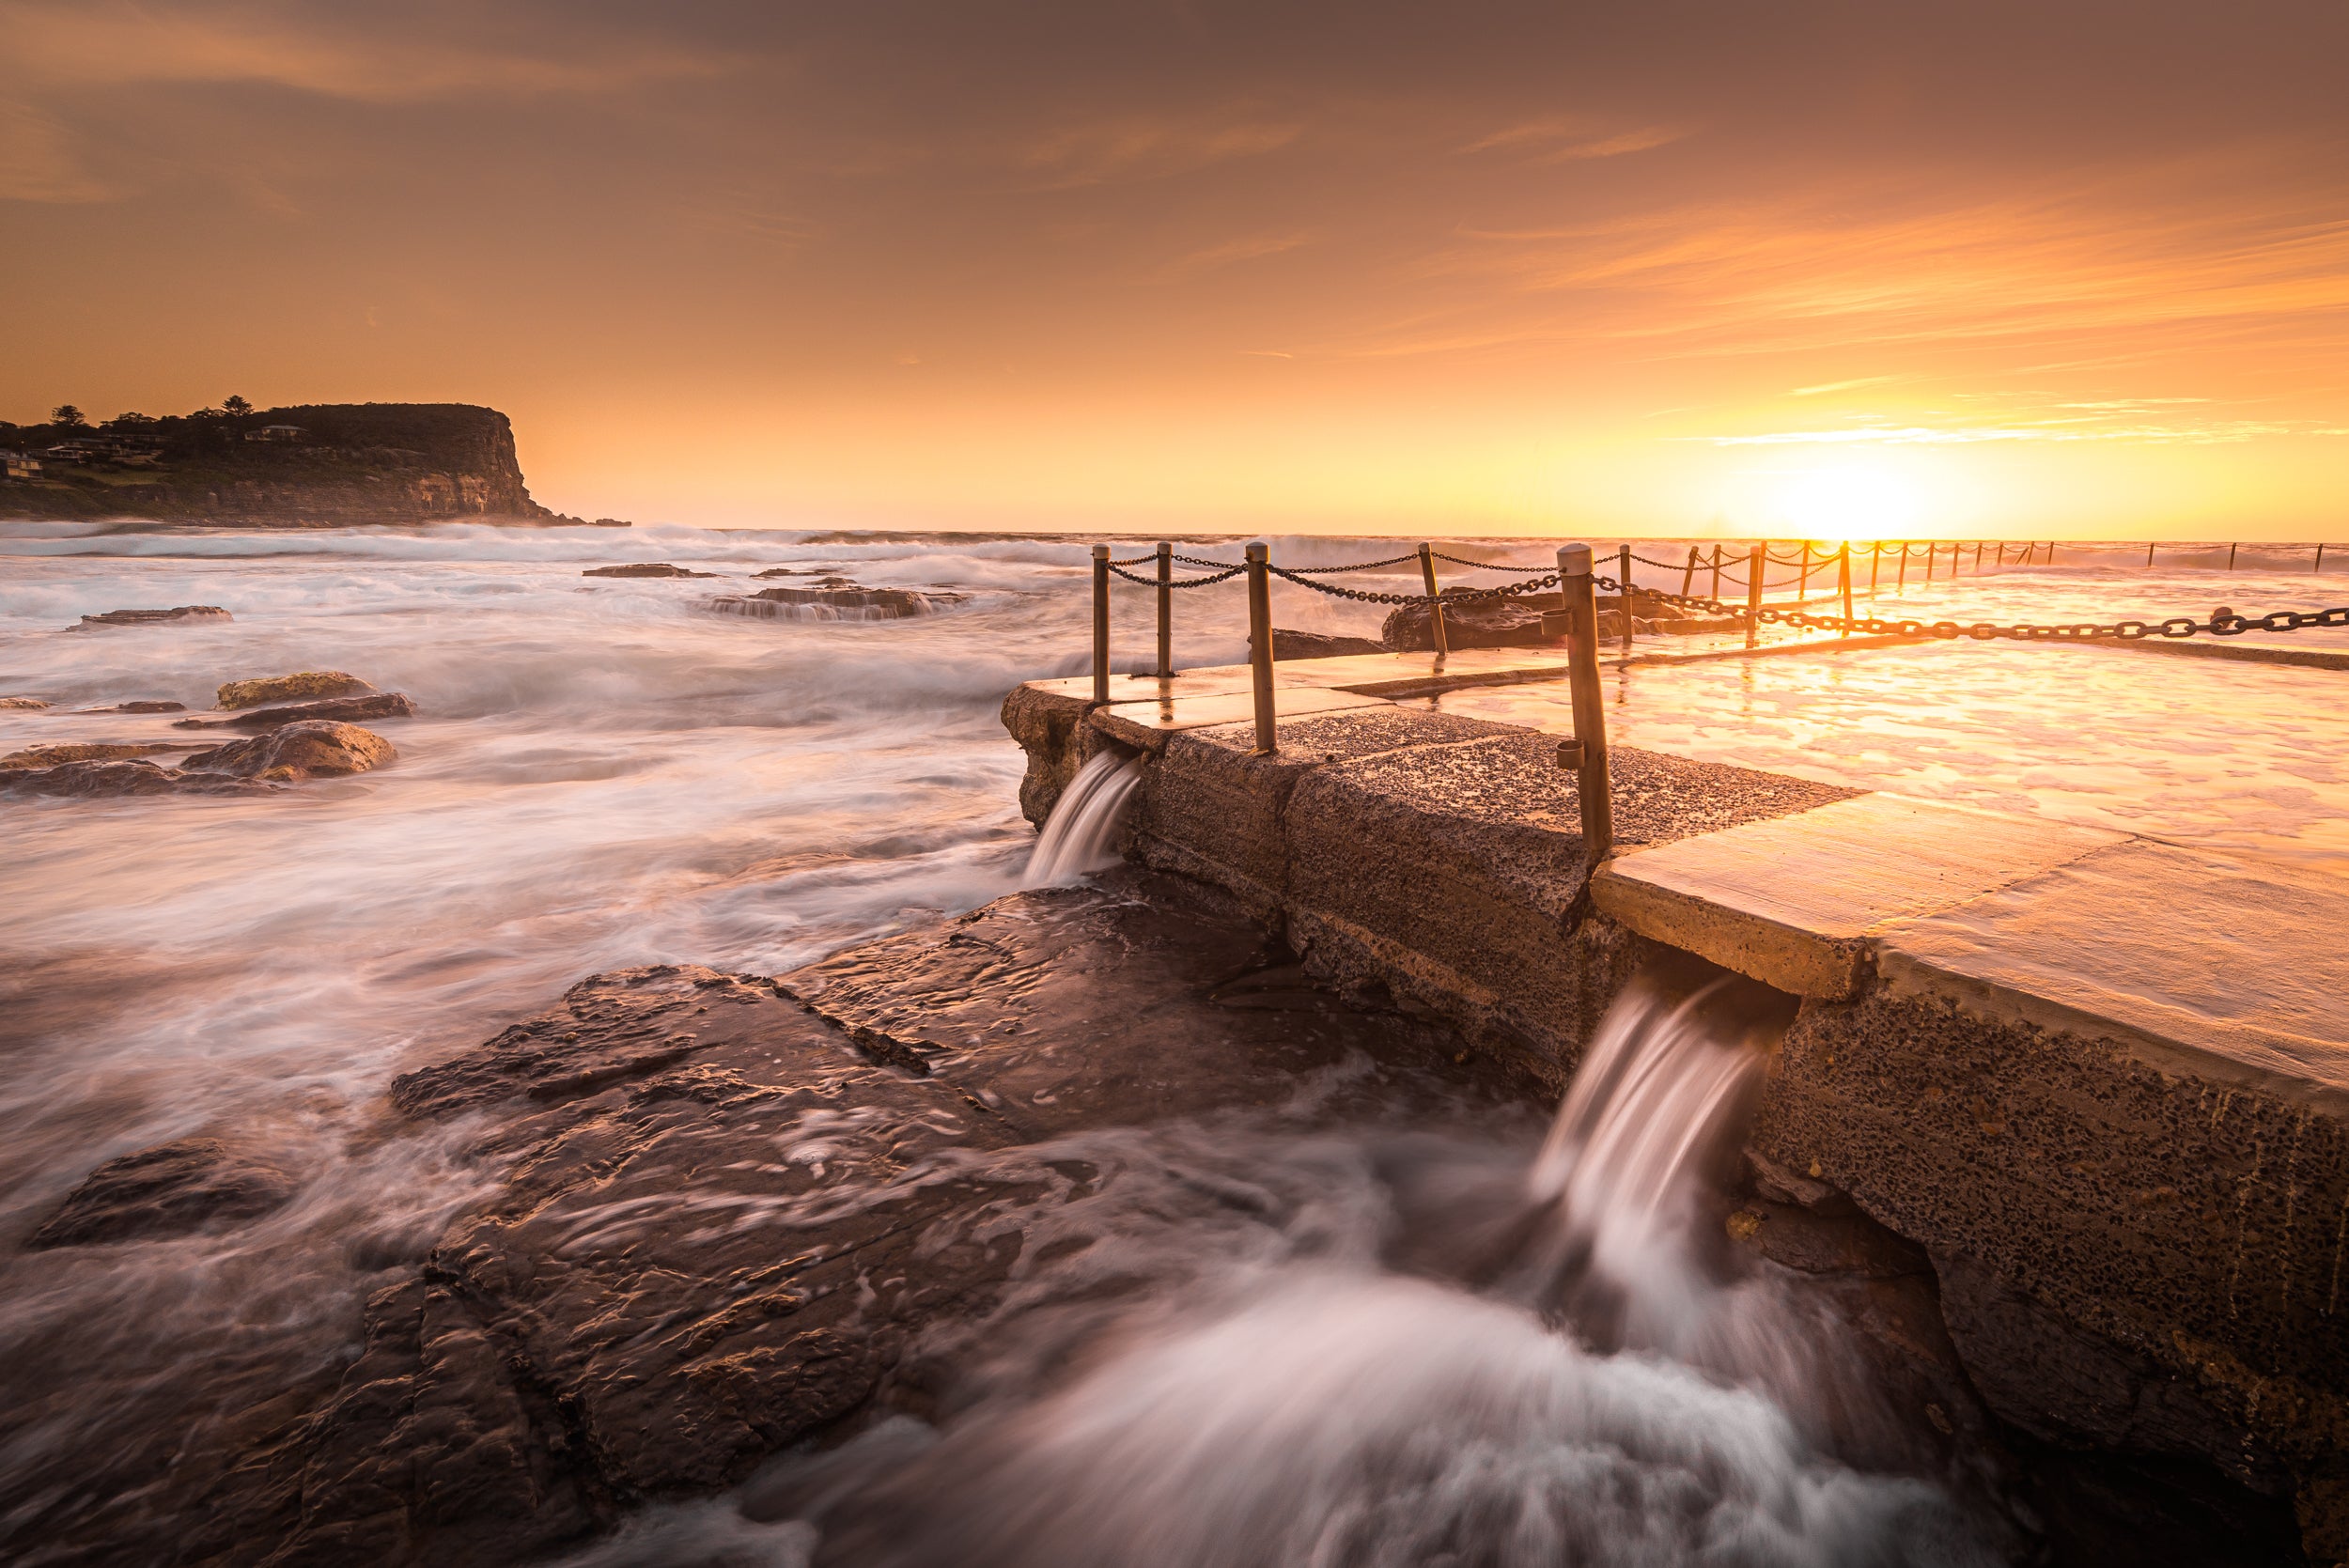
xmin=0 ymin=0 xmax=2349 ymax=540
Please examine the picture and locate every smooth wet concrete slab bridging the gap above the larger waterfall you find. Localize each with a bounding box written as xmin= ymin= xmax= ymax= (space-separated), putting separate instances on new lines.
xmin=1591 ymin=793 xmax=2128 ymax=998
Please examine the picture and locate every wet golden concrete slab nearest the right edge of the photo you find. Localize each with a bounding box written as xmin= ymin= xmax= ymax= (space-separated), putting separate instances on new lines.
xmin=1877 ymin=838 xmax=2349 ymax=1110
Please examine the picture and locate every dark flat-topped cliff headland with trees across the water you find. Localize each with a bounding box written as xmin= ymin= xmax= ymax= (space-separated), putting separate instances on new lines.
xmin=0 ymin=404 xmax=564 ymax=528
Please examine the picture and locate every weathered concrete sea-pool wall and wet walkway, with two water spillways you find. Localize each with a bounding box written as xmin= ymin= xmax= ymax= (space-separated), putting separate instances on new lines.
xmin=1003 ymin=648 xmax=2349 ymax=1563
